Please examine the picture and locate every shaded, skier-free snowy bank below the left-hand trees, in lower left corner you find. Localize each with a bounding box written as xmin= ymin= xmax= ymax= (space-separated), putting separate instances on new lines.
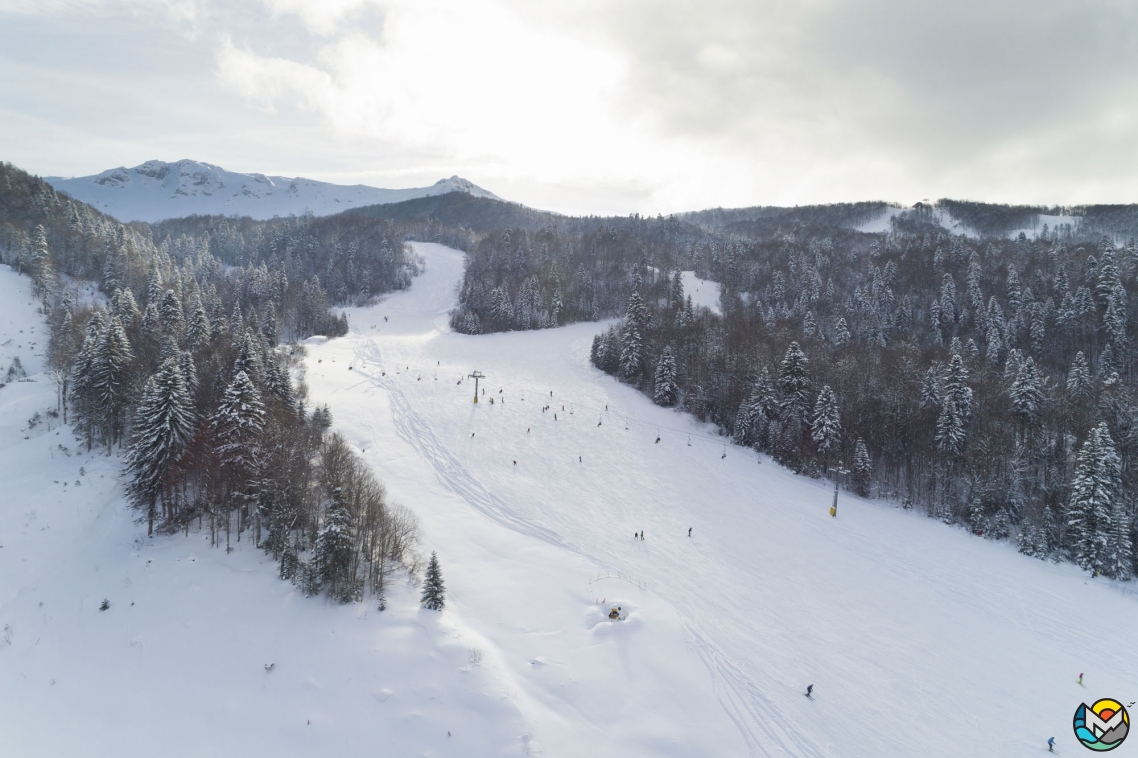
xmin=0 ymin=266 xmax=529 ymax=758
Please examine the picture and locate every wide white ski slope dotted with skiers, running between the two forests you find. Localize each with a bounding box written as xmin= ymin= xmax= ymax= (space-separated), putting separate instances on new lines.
xmin=306 ymin=245 xmax=1138 ymax=757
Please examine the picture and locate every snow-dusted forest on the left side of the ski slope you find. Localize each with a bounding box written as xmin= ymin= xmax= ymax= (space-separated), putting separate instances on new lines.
xmin=0 ymin=164 xmax=420 ymax=608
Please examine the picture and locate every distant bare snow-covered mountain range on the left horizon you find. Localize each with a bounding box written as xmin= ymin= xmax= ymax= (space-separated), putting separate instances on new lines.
xmin=46 ymin=160 xmax=501 ymax=222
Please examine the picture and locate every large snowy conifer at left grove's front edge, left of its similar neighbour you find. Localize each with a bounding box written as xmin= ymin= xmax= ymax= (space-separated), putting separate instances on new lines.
xmin=126 ymin=359 xmax=197 ymax=536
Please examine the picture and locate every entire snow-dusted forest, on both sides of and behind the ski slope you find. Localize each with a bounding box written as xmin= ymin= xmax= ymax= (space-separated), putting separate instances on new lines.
xmin=0 ymin=153 xmax=1138 ymax=582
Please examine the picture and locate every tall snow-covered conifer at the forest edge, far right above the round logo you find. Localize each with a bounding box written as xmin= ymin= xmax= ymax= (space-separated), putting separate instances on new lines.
xmin=1066 ymin=421 xmax=1122 ymax=572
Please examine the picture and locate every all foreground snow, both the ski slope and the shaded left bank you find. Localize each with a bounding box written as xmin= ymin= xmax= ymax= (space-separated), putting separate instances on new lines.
xmin=0 ymin=245 xmax=1138 ymax=757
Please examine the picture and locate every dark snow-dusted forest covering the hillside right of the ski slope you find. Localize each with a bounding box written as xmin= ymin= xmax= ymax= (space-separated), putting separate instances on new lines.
xmin=443 ymin=198 xmax=1138 ymax=578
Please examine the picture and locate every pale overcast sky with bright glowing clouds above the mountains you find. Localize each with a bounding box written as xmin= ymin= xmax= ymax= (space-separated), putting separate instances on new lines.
xmin=0 ymin=0 xmax=1138 ymax=214
